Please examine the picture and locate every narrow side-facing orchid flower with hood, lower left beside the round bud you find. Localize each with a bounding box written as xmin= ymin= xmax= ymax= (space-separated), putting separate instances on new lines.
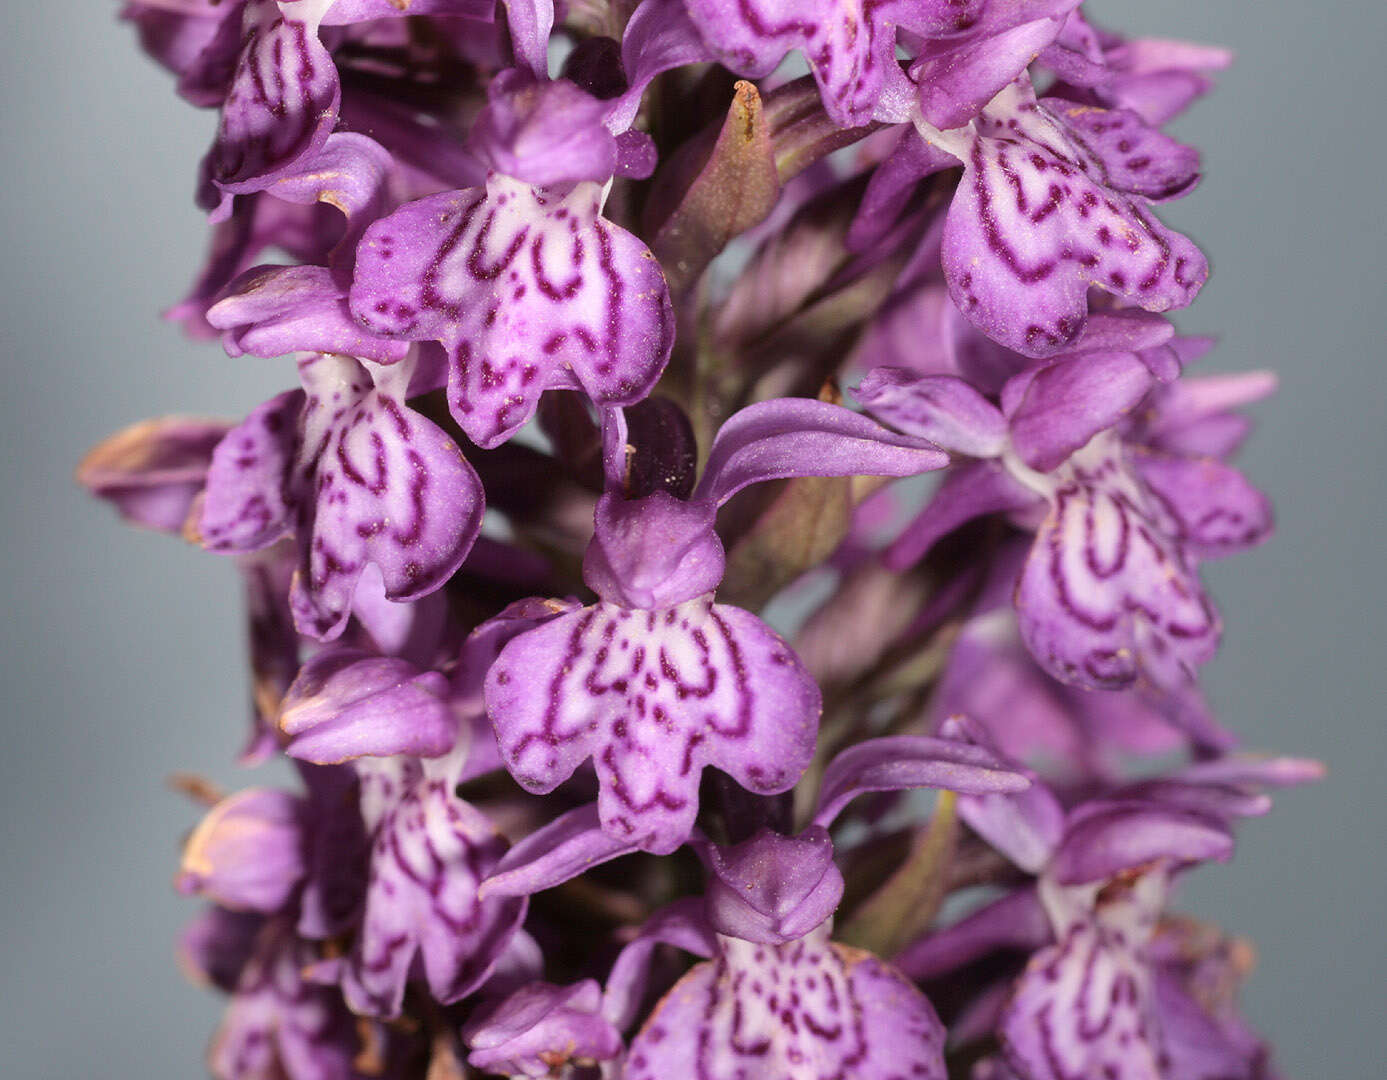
xmin=282 ymin=649 xmax=526 ymax=1018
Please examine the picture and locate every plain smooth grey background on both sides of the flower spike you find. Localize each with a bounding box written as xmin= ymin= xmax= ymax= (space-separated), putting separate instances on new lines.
xmin=0 ymin=0 xmax=1387 ymax=1080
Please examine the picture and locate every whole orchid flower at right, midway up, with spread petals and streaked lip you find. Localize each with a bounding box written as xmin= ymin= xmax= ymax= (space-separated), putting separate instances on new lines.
xmin=859 ymin=331 xmax=1270 ymax=701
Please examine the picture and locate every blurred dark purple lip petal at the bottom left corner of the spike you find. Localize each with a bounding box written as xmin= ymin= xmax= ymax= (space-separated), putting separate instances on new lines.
xmin=208 ymin=919 xmax=358 ymax=1080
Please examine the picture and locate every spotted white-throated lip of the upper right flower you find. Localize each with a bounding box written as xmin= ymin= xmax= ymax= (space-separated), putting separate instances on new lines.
xmin=943 ymin=83 xmax=1208 ymax=358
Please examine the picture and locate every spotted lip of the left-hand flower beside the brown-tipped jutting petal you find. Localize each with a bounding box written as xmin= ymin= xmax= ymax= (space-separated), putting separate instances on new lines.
xmin=197 ymin=354 xmax=483 ymax=639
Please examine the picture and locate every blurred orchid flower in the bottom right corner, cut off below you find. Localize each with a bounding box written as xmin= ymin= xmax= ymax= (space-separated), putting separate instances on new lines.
xmin=897 ymin=721 xmax=1320 ymax=1080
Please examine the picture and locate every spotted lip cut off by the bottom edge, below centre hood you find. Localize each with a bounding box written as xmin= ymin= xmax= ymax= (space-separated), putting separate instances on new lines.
xmin=624 ymin=927 xmax=946 ymax=1080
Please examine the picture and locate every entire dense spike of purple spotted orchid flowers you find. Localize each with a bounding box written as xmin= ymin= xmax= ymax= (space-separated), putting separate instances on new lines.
xmin=79 ymin=0 xmax=1319 ymax=1080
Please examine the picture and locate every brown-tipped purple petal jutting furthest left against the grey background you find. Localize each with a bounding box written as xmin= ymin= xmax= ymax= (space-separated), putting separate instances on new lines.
xmin=78 ymin=416 xmax=230 ymax=535
